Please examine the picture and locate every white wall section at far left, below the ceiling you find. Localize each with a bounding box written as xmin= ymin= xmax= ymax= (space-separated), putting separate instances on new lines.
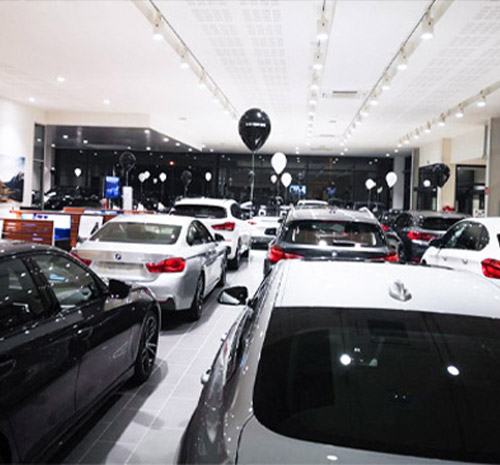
xmin=0 ymin=98 xmax=45 ymax=205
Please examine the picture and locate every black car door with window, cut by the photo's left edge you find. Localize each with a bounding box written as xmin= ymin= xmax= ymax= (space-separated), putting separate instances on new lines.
xmin=0 ymin=258 xmax=82 ymax=461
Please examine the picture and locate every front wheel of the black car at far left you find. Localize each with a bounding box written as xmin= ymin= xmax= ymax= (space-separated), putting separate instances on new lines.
xmin=132 ymin=310 xmax=159 ymax=384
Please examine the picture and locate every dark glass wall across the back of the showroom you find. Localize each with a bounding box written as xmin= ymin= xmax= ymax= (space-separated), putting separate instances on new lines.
xmin=54 ymin=149 xmax=403 ymax=206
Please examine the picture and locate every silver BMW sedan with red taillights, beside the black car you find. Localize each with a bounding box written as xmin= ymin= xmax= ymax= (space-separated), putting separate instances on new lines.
xmin=73 ymin=215 xmax=227 ymax=319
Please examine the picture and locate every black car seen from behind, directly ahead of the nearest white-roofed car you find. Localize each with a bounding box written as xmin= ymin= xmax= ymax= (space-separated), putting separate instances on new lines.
xmin=264 ymin=208 xmax=398 ymax=273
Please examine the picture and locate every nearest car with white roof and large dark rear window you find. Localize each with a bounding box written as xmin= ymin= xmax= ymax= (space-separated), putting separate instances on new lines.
xmin=178 ymin=260 xmax=500 ymax=464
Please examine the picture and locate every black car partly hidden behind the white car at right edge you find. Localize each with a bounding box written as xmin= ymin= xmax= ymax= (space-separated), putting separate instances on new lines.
xmin=392 ymin=211 xmax=465 ymax=263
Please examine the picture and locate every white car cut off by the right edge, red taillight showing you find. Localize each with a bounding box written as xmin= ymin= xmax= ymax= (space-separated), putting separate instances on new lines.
xmin=422 ymin=217 xmax=500 ymax=284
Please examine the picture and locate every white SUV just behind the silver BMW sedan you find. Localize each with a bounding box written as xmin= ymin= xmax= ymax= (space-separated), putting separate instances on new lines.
xmin=170 ymin=197 xmax=252 ymax=270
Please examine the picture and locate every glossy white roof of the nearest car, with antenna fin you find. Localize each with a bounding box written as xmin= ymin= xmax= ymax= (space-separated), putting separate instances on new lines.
xmin=275 ymin=260 xmax=500 ymax=318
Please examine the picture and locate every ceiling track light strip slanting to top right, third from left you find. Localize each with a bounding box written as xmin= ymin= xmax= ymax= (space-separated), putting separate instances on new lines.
xmin=341 ymin=0 xmax=453 ymax=150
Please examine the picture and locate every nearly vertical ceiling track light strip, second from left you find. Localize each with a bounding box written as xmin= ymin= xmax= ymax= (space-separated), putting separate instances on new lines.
xmin=306 ymin=0 xmax=337 ymax=146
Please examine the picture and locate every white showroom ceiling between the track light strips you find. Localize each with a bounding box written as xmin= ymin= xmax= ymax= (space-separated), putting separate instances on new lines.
xmin=0 ymin=0 xmax=500 ymax=154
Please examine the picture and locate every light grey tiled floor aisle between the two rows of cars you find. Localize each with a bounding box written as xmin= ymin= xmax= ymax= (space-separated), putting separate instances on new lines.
xmin=57 ymin=250 xmax=265 ymax=464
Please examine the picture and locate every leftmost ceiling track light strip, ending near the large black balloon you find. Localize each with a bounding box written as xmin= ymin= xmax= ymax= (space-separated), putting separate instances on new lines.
xmin=132 ymin=0 xmax=239 ymax=119
